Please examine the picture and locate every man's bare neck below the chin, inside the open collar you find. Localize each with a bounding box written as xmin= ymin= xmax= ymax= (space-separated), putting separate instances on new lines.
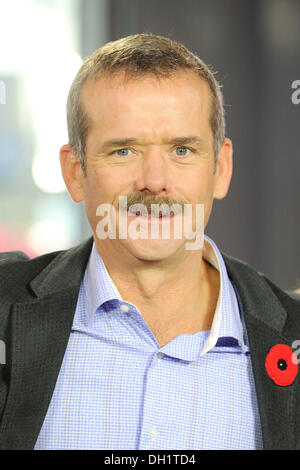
xmin=96 ymin=239 xmax=220 ymax=329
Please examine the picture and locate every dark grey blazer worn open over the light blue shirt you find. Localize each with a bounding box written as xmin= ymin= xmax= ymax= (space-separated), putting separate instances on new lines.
xmin=0 ymin=238 xmax=300 ymax=449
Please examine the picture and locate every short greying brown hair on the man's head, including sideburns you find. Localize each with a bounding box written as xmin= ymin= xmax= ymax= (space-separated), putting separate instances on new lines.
xmin=67 ymin=33 xmax=225 ymax=174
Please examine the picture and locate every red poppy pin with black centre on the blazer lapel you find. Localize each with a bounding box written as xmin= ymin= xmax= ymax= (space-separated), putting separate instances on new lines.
xmin=265 ymin=344 xmax=298 ymax=387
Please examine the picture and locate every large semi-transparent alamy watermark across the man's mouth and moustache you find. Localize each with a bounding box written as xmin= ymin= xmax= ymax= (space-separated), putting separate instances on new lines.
xmin=96 ymin=196 xmax=204 ymax=250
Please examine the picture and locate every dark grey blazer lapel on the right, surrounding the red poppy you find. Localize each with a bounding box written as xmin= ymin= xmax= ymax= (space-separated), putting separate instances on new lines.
xmin=223 ymin=254 xmax=300 ymax=450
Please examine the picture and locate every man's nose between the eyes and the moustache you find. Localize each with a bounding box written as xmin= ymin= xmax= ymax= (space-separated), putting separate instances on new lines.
xmin=136 ymin=149 xmax=170 ymax=194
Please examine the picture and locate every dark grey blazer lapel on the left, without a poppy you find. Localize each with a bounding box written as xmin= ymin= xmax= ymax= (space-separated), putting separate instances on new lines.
xmin=0 ymin=239 xmax=92 ymax=449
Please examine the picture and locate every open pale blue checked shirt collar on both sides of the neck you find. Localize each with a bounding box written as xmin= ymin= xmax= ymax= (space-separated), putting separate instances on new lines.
xmin=83 ymin=235 xmax=247 ymax=356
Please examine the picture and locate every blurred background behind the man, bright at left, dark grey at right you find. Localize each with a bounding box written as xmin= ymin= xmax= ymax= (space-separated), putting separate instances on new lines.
xmin=0 ymin=0 xmax=300 ymax=289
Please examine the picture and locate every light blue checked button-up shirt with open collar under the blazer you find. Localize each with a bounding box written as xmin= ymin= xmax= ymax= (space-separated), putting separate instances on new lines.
xmin=35 ymin=236 xmax=262 ymax=450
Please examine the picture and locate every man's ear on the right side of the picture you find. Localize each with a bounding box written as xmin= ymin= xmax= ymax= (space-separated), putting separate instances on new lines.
xmin=214 ymin=138 xmax=233 ymax=199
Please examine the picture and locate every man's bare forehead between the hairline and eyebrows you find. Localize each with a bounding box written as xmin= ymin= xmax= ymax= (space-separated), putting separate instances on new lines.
xmin=81 ymin=71 xmax=211 ymax=136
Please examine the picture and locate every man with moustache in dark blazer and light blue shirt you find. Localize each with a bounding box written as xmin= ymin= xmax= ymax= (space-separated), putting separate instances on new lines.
xmin=0 ymin=34 xmax=300 ymax=450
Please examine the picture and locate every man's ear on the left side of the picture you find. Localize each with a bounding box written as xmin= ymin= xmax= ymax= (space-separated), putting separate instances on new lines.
xmin=59 ymin=145 xmax=84 ymax=202
